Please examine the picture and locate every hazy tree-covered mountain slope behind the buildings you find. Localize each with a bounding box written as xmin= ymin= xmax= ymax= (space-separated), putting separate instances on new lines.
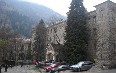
xmin=0 ymin=0 xmax=65 ymax=37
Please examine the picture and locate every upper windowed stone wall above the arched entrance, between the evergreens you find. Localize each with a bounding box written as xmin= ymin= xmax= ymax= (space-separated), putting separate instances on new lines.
xmin=47 ymin=21 xmax=66 ymax=44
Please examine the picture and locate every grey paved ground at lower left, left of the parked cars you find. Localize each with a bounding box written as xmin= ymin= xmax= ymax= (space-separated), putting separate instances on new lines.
xmin=1 ymin=65 xmax=39 ymax=73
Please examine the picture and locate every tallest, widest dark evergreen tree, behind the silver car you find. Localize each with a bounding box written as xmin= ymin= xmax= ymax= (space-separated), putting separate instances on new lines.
xmin=62 ymin=0 xmax=88 ymax=63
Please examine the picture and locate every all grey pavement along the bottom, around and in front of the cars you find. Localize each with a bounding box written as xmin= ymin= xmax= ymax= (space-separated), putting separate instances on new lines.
xmin=1 ymin=65 xmax=116 ymax=73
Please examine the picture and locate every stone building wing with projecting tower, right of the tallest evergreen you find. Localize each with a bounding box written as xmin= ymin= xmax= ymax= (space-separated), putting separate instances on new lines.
xmin=87 ymin=0 xmax=116 ymax=68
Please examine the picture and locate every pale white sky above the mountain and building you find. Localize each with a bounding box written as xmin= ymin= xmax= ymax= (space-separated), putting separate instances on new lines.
xmin=21 ymin=0 xmax=116 ymax=16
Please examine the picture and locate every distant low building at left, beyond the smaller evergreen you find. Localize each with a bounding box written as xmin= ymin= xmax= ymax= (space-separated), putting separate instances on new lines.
xmin=12 ymin=38 xmax=32 ymax=63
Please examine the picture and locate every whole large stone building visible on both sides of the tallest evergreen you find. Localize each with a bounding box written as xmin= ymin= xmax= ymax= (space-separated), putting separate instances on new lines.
xmin=46 ymin=0 xmax=116 ymax=67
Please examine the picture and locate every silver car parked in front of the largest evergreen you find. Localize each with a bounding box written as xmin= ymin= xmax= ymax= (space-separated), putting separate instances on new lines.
xmin=70 ymin=61 xmax=94 ymax=71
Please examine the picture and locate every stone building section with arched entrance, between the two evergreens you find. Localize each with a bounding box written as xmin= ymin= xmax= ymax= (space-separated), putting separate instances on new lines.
xmin=46 ymin=21 xmax=66 ymax=61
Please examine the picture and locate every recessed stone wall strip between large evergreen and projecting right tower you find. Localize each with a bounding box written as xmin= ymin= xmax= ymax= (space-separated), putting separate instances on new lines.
xmin=87 ymin=11 xmax=96 ymax=60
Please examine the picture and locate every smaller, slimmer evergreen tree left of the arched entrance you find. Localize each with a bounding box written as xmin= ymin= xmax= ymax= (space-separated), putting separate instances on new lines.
xmin=34 ymin=19 xmax=47 ymax=61
